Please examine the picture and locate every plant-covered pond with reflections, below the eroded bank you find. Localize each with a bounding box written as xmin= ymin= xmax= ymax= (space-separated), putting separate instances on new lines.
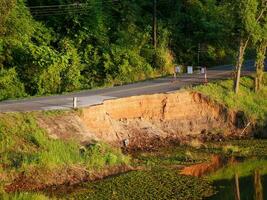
xmin=49 ymin=141 xmax=267 ymax=200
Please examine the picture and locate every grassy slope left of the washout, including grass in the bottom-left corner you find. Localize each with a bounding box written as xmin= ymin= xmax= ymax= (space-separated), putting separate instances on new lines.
xmin=0 ymin=112 xmax=130 ymax=199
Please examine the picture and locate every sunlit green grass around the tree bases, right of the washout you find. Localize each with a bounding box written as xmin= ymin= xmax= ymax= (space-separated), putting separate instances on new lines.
xmin=194 ymin=73 xmax=267 ymax=123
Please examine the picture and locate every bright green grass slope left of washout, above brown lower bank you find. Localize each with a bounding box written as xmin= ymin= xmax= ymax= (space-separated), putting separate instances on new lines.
xmin=0 ymin=113 xmax=129 ymax=170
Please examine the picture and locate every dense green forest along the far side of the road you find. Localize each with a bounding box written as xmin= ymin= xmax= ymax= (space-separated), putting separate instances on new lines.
xmin=0 ymin=0 xmax=267 ymax=100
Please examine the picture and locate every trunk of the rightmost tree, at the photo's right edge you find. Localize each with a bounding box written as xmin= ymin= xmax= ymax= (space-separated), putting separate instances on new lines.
xmin=254 ymin=40 xmax=267 ymax=92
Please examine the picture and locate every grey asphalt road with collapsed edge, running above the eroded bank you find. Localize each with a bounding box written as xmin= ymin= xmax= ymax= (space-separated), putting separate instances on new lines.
xmin=0 ymin=61 xmax=267 ymax=112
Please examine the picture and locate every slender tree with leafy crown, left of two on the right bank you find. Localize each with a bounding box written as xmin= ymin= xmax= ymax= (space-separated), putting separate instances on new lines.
xmin=233 ymin=0 xmax=267 ymax=94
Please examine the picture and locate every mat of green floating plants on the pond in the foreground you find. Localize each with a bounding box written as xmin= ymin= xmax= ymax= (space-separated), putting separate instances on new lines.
xmin=72 ymin=168 xmax=216 ymax=200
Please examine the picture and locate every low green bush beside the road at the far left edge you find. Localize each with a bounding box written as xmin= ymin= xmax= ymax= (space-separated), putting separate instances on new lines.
xmin=0 ymin=68 xmax=27 ymax=100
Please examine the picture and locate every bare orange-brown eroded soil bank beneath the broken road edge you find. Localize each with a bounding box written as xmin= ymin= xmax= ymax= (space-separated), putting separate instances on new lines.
xmin=38 ymin=91 xmax=250 ymax=149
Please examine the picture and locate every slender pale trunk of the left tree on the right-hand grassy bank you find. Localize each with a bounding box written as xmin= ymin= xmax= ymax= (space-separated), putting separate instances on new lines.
xmin=234 ymin=39 xmax=246 ymax=94
